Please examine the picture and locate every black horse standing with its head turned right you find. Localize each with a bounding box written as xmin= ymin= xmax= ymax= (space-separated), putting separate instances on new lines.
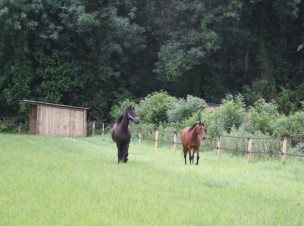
xmin=112 ymin=106 xmax=139 ymax=162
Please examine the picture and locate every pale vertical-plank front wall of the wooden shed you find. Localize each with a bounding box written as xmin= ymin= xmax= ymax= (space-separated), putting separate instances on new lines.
xmin=37 ymin=105 xmax=87 ymax=137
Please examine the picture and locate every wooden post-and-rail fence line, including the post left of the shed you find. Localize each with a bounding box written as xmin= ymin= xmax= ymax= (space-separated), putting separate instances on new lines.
xmin=2 ymin=121 xmax=304 ymax=163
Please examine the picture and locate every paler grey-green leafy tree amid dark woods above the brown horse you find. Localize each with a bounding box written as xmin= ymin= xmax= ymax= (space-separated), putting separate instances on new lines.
xmin=154 ymin=1 xmax=218 ymax=99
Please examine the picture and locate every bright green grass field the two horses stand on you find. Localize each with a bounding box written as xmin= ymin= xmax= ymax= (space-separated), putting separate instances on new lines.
xmin=0 ymin=134 xmax=304 ymax=226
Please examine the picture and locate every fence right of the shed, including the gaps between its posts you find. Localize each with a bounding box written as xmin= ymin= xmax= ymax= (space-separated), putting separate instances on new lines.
xmin=86 ymin=122 xmax=304 ymax=163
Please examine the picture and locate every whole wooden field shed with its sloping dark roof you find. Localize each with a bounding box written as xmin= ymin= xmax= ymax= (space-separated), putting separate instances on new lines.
xmin=20 ymin=100 xmax=88 ymax=137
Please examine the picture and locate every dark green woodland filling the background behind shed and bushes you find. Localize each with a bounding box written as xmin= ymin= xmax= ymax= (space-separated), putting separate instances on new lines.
xmin=0 ymin=0 xmax=304 ymax=118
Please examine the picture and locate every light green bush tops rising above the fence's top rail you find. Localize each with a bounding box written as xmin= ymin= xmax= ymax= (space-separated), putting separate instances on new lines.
xmin=111 ymin=91 xmax=304 ymax=140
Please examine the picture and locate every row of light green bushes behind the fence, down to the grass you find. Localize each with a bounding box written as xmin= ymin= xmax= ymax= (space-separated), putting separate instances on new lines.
xmin=104 ymin=91 xmax=304 ymax=159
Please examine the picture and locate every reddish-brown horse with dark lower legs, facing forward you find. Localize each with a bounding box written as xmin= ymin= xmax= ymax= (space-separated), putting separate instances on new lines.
xmin=181 ymin=122 xmax=206 ymax=165
